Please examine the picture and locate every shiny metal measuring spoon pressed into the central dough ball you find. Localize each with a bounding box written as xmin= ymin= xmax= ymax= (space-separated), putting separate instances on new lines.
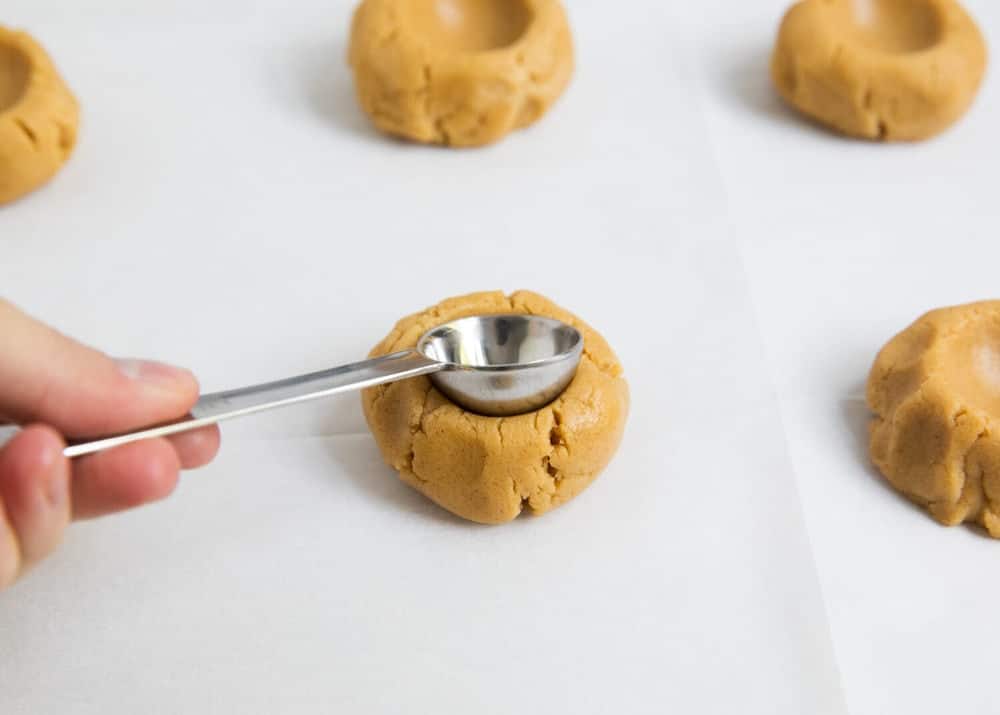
xmin=63 ymin=315 xmax=583 ymax=457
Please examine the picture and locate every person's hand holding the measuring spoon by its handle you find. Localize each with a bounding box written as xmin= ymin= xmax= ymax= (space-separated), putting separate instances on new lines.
xmin=0 ymin=299 xmax=219 ymax=589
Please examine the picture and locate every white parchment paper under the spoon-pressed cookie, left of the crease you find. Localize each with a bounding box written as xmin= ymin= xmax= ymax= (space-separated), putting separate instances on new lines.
xmin=0 ymin=0 xmax=843 ymax=715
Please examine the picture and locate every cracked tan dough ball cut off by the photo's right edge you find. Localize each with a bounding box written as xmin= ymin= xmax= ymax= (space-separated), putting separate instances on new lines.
xmin=868 ymin=301 xmax=1000 ymax=538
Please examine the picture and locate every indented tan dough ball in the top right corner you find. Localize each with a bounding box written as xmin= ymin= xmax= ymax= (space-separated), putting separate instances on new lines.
xmin=771 ymin=0 xmax=986 ymax=140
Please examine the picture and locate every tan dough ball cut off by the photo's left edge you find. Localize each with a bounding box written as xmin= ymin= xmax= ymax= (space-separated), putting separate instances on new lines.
xmin=0 ymin=27 xmax=80 ymax=204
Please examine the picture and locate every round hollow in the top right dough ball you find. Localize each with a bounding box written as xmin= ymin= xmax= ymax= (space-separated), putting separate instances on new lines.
xmin=850 ymin=0 xmax=941 ymax=53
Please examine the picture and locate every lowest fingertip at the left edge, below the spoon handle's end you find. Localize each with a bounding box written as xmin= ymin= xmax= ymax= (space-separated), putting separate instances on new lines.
xmin=0 ymin=426 xmax=70 ymax=588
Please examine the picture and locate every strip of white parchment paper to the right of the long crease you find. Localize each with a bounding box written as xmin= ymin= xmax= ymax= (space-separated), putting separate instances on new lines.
xmin=691 ymin=0 xmax=1000 ymax=715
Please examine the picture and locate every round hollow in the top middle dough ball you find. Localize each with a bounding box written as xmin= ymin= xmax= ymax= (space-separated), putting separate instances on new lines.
xmin=408 ymin=0 xmax=531 ymax=52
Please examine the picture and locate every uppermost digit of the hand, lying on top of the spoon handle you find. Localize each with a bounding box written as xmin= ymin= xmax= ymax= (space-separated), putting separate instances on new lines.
xmin=0 ymin=299 xmax=198 ymax=438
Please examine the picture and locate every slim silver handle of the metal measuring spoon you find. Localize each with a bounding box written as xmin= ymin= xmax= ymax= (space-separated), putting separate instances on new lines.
xmin=63 ymin=350 xmax=444 ymax=457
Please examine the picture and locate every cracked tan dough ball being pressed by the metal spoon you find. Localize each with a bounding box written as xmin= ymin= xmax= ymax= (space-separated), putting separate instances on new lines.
xmin=361 ymin=291 xmax=629 ymax=524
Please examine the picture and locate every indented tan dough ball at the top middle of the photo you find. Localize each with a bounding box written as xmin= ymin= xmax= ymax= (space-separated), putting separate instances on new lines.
xmin=349 ymin=0 xmax=573 ymax=146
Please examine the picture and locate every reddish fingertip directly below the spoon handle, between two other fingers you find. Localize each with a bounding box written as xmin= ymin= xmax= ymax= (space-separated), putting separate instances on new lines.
xmin=71 ymin=438 xmax=181 ymax=519
